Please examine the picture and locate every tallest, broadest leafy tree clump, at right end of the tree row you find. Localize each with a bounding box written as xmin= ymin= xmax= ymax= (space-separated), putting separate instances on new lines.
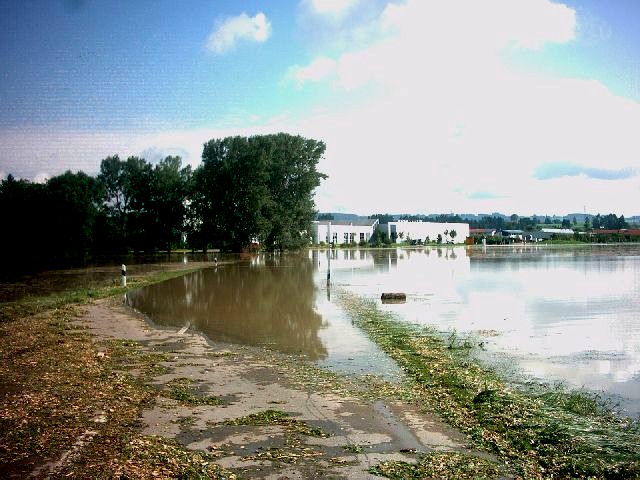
xmin=191 ymin=133 xmax=325 ymax=251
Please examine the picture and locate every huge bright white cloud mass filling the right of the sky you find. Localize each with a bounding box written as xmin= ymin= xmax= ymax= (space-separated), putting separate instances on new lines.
xmin=284 ymin=0 xmax=640 ymax=213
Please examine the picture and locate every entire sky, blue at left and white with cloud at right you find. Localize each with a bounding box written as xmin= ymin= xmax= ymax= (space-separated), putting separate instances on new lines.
xmin=0 ymin=0 xmax=640 ymax=216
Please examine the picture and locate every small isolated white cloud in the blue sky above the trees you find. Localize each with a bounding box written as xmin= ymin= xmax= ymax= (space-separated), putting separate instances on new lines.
xmin=207 ymin=12 xmax=271 ymax=55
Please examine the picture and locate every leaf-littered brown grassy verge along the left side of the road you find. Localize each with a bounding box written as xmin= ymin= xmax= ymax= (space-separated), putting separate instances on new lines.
xmin=0 ymin=268 xmax=235 ymax=478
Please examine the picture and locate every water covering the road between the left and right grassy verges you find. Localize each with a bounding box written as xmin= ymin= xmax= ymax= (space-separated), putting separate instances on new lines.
xmin=127 ymin=255 xmax=400 ymax=377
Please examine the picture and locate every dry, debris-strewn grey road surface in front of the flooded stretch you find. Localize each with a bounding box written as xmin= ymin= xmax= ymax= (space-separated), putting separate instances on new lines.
xmin=78 ymin=299 xmax=490 ymax=479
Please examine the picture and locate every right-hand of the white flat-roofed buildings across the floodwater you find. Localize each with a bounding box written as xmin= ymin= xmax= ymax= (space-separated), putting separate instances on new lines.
xmin=378 ymin=220 xmax=469 ymax=243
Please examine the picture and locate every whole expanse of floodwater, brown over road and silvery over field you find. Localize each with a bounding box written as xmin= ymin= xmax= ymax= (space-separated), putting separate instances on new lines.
xmin=128 ymin=245 xmax=640 ymax=414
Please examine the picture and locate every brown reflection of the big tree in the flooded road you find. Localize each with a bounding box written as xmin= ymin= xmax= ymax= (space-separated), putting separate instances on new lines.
xmin=131 ymin=257 xmax=327 ymax=360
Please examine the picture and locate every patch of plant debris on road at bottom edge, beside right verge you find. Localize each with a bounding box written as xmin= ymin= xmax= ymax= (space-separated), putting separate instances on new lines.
xmin=369 ymin=453 xmax=504 ymax=480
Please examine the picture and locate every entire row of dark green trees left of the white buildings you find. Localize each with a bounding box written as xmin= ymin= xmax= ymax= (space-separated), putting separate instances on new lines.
xmin=0 ymin=133 xmax=325 ymax=270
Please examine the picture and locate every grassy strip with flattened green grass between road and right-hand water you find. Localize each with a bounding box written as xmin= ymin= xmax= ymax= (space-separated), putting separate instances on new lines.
xmin=339 ymin=292 xmax=640 ymax=478
